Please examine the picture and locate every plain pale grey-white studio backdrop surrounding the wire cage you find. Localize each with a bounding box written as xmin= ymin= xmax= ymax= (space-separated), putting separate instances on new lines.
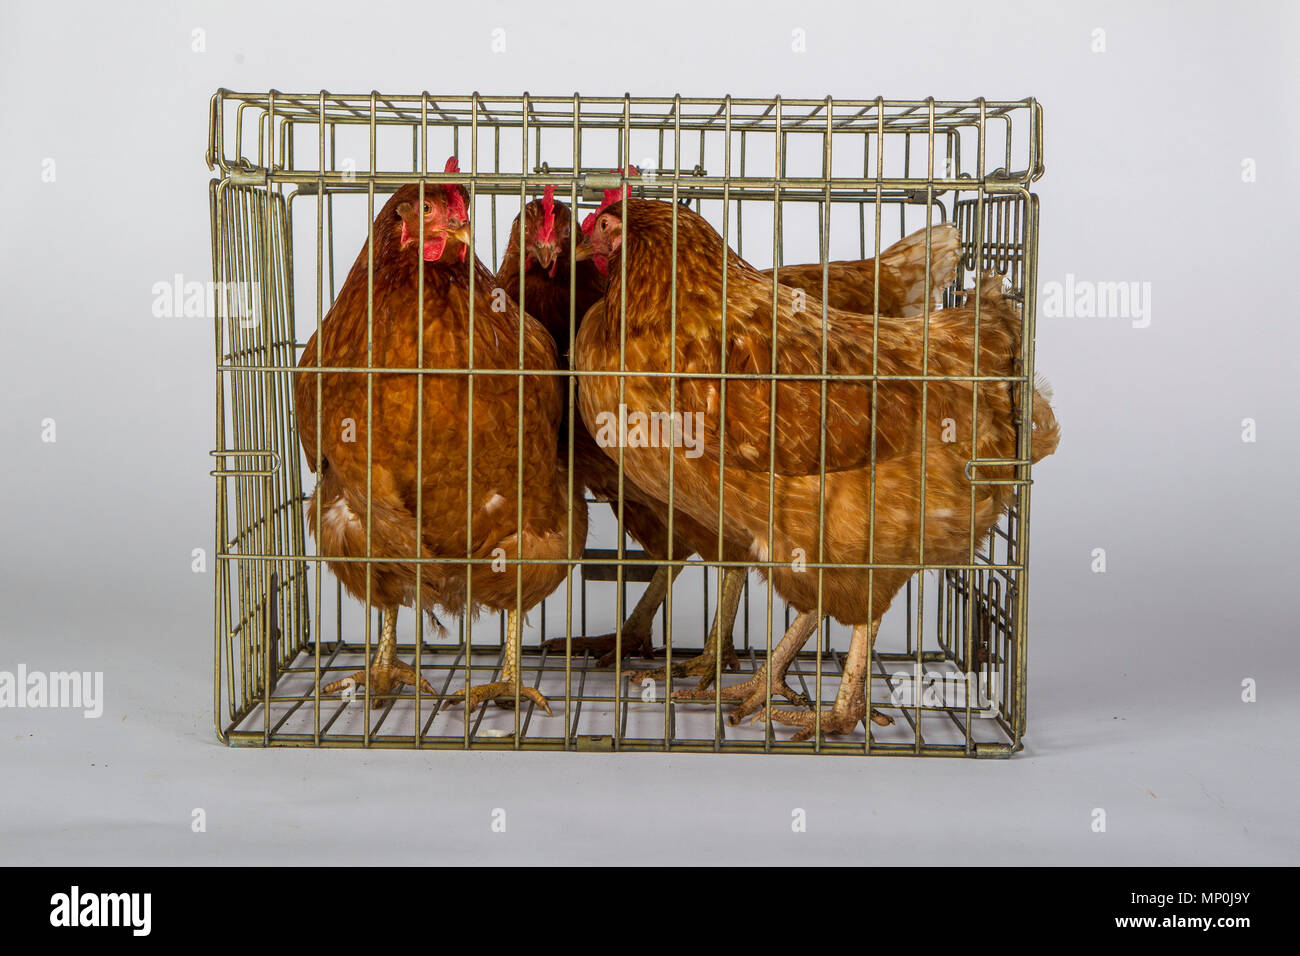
xmin=0 ymin=0 xmax=1300 ymax=865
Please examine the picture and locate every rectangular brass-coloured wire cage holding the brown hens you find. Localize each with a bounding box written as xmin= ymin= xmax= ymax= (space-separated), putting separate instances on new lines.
xmin=207 ymin=90 xmax=1043 ymax=757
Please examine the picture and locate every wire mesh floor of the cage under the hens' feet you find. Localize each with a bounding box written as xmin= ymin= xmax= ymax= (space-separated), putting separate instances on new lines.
xmin=231 ymin=645 xmax=1008 ymax=756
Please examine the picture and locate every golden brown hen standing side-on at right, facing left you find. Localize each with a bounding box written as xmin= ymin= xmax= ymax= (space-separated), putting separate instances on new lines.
xmin=573 ymin=199 xmax=1058 ymax=739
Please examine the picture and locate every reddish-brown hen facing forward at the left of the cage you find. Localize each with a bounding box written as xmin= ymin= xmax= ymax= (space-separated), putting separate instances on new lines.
xmin=295 ymin=159 xmax=586 ymax=714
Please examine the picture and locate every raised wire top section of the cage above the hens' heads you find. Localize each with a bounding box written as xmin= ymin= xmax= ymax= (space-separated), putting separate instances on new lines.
xmin=205 ymin=88 xmax=1044 ymax=191
